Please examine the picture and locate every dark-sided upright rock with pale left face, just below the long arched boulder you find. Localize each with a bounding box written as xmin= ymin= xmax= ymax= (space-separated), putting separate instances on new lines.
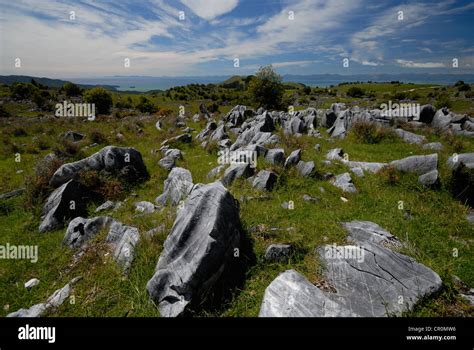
xmin=39 ymin=180 xmax=87 ymax=233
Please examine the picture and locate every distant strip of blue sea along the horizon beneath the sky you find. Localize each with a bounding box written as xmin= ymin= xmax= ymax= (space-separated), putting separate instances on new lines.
xmin=66 ymin=74 xmax=474 ymax=92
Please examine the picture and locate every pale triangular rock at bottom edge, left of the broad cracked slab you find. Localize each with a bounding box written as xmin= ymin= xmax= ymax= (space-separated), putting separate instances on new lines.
xmin=259 ymin=270 xmax=357 ymax=317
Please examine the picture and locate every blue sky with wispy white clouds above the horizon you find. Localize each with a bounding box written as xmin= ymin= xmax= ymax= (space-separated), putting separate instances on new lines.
xmin=0 ymin=0 xmax=474 ymax=78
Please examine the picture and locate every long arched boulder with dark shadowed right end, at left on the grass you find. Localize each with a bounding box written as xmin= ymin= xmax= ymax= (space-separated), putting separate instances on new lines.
xmin=49 ymin=146 xmax=149 ymax=187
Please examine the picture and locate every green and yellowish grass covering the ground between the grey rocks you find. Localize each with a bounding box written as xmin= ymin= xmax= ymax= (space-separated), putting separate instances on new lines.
xmin=0 ymin=84 xmax=474 ymax=317
